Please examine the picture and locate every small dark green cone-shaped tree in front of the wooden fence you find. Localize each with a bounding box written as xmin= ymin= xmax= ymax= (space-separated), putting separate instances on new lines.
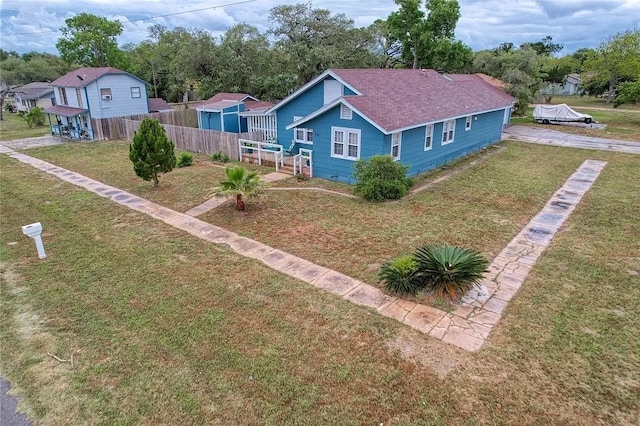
xmin=129 ymin=118 xmax=176 ymax=187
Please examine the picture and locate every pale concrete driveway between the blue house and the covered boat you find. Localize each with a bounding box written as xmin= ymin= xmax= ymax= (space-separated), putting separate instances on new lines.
xmin=502 ymin=125 xmax=640 ymax=154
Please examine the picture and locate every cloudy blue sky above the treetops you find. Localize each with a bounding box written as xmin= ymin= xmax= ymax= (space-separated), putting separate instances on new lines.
xmin=0 ymin=0 xmax=640 ymax=54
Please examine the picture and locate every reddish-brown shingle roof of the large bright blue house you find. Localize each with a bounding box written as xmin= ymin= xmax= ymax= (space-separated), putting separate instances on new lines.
xmin=331 ymin=69 xmax=514 ymax=131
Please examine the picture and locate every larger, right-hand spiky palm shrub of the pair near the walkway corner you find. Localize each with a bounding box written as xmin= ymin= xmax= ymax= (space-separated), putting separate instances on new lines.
xmin=413 ymin=244 xmax=489 ymax=299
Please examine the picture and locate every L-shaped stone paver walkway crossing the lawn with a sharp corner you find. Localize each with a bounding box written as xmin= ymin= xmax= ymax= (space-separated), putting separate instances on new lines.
xmin=0 ymin=145 xmax=606 ymax=351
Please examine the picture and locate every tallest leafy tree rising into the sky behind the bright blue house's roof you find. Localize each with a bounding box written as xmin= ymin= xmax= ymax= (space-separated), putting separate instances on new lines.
xmin=387 ymin=0 xmax=473 ymax=72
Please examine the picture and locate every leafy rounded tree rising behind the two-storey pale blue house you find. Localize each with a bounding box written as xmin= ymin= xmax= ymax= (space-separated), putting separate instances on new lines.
xmin=56 ymin=12 xmax=127 ymax=69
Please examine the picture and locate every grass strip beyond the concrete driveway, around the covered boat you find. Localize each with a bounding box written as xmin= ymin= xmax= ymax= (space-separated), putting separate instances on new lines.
xmin=511 ymin=107 xmax=640 ymax=142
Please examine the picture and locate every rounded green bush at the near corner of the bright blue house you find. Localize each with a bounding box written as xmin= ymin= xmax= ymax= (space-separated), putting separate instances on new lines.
xmin=354 ymin=155 xmax=412 ymax=201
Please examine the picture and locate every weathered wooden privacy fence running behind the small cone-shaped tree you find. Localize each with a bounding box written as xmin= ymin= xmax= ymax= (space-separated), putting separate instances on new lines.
xmin=97 ymin=118 xmax=262 ymax=161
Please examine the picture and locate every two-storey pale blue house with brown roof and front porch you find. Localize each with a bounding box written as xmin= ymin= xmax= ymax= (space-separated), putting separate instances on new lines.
xmin=44 ymin=67 xmax=149 ymax=139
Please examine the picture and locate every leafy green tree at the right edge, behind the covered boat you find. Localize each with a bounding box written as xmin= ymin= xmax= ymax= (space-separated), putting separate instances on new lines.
xmin=584 ymin=30 xmax=640 ymax=104
